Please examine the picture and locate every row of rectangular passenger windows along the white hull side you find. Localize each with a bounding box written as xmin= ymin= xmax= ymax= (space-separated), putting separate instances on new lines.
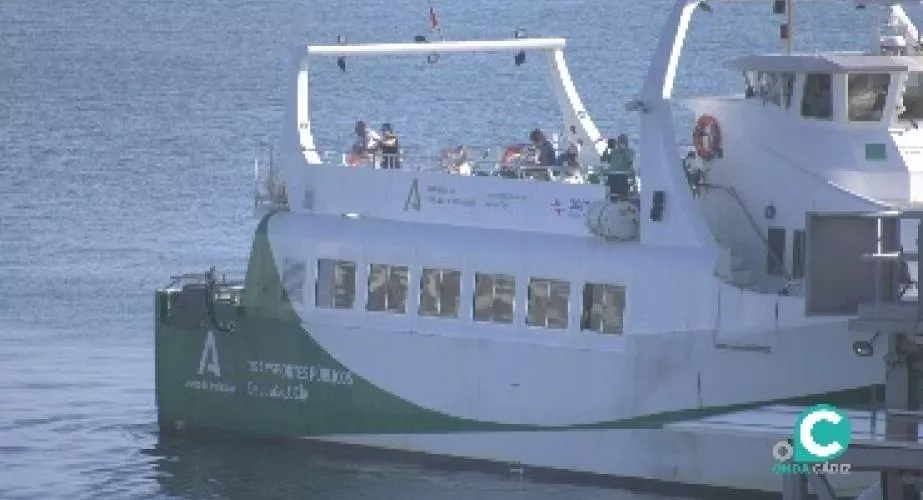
xmin=282 ymin=258 xmax=625 ymax=334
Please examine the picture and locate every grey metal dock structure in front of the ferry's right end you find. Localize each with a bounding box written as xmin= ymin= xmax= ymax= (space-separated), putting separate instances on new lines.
xmin=782 ymin=210 xmax=923 ymax=500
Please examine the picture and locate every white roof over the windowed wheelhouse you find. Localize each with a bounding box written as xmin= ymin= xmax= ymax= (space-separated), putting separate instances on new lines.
xmin=728 ymin=52 xmax=923 ymax=73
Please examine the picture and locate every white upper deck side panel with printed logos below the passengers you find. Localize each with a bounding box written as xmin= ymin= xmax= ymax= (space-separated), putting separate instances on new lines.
xmin=257 ymin=148 xmax=639 ymax=240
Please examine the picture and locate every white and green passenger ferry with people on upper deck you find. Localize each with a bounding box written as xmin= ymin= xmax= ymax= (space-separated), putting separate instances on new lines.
xmin=156 ymin=0 xmax=923 ymax=491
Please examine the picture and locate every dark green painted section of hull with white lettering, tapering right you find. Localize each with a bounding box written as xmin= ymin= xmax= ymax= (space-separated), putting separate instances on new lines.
xmin=155 ymin=214 xmax=868 ymax=436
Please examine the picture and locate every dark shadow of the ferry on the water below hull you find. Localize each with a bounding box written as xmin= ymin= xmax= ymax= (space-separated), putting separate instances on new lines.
xmin=143 ymin=431 xmax=778 ymax=500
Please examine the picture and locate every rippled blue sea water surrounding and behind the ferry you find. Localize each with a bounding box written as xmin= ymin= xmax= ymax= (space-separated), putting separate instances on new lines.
xmin=0 ymin=0 xmax=908 ymax=500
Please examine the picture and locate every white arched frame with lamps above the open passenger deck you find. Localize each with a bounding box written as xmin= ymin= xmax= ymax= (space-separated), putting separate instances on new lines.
xmin=297 ymin=38 xmax=605 ymax=164
